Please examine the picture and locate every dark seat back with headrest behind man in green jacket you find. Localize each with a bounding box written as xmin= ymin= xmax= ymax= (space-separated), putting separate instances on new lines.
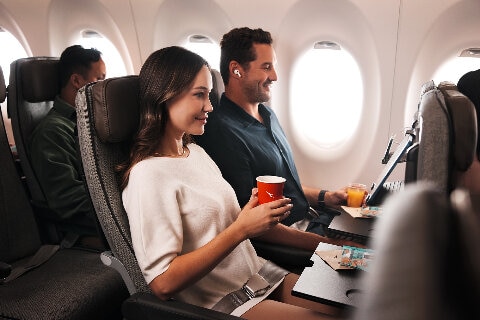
xmin=7 ymin=57 xmax=60 ymax=209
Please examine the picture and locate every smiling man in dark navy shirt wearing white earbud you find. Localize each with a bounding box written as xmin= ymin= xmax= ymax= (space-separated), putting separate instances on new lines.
xmin=195 ymin=28 xmax=347 ymax=235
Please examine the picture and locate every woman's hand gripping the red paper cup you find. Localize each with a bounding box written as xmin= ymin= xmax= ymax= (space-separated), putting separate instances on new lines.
xmin=235 ymin=188 xmax=293 ymax=239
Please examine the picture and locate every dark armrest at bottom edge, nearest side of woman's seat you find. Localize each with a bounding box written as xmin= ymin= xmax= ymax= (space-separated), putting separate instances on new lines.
xmin=122 ymin=292 xmax=246 ymax=320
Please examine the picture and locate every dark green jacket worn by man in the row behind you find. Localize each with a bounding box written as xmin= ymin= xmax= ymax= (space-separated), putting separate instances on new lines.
xmin=29 ymin=96 xmax=94 ymax=223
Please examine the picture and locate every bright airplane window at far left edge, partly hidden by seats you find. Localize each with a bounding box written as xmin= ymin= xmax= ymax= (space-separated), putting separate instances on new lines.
xmin=0 ymin=27 xmax=28 ymax=146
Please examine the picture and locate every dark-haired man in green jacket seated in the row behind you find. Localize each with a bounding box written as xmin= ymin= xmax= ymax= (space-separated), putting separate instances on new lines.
xmin=29 ymin=45 xmax=106 ymax=244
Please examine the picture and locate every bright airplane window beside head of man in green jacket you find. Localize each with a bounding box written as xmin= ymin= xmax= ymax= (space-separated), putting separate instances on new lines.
xmin=78 ymin=30 xmax=127 ymax=78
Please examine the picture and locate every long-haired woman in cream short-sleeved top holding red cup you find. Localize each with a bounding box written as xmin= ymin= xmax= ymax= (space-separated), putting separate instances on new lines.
xmin=122 ymin=47 xmax=339 ymax=319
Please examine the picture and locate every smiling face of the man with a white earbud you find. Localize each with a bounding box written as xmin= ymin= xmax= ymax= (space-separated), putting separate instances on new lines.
xmin=242 ymin=44 xmax=277 ymax=103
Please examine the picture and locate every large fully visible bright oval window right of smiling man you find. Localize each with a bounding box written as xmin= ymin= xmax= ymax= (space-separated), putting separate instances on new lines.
xmin=290 ymin=41 xmax=363 ymax=149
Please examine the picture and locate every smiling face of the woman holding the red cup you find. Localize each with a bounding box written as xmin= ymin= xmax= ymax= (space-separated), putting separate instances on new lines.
xmin=167 ymin=66 xmax=213 ymax=135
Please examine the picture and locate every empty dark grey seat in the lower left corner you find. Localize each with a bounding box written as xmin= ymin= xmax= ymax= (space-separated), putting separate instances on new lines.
xmin=0 ymin=64 xmax=128 ymax=320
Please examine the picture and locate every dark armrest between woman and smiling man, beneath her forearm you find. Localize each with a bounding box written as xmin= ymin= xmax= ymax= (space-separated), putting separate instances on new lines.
xmin=250 ymin=239 xmax=313 ymax=271
